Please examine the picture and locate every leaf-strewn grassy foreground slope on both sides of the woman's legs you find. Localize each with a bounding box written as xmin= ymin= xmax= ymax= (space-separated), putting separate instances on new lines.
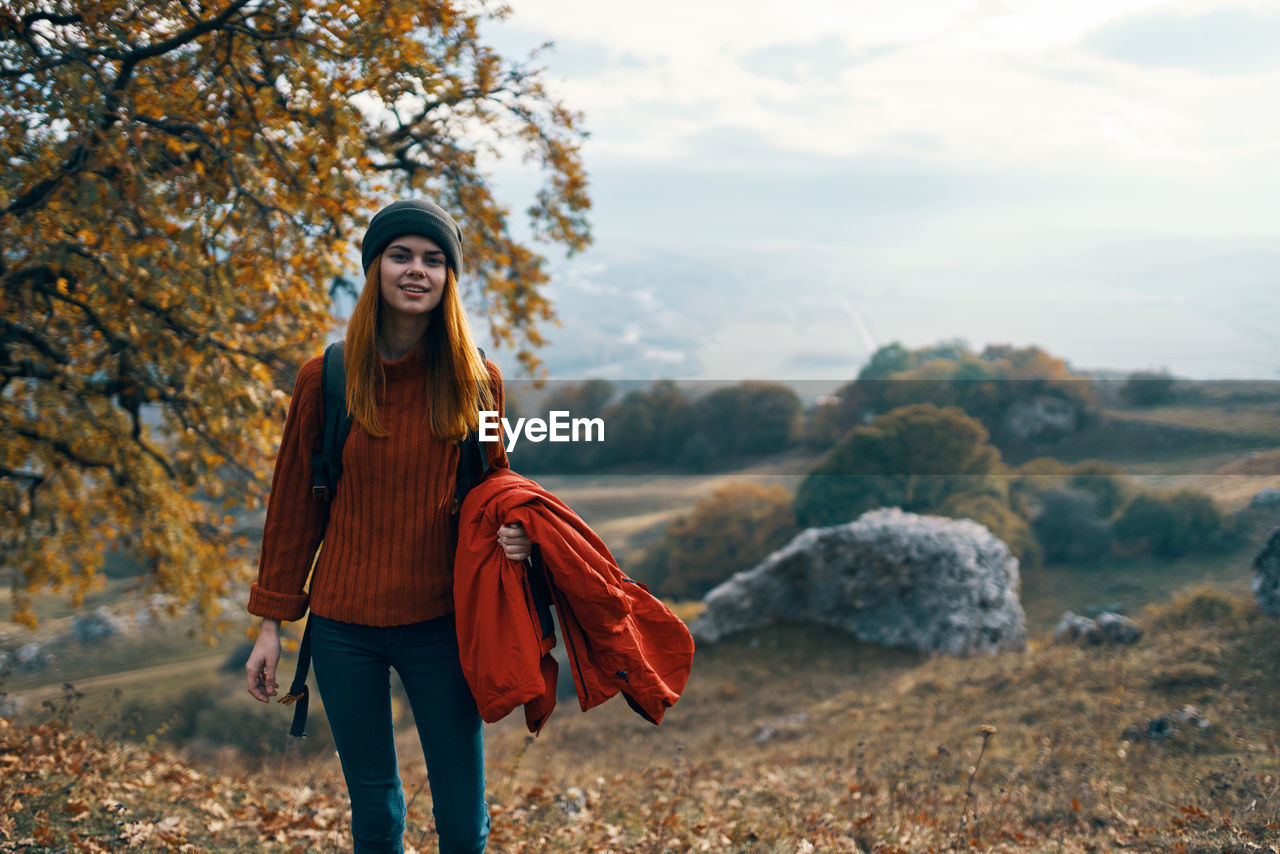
xmin=0 ymin=594 xmax=1280 ymax=854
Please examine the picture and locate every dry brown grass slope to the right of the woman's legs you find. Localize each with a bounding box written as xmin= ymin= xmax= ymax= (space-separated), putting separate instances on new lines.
xmin=473 ymin=594 xmax=1280 ymax=851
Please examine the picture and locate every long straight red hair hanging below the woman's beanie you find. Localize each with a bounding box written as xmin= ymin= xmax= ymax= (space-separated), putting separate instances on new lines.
xmin=344 ymin=255 xmax=495 ymax=439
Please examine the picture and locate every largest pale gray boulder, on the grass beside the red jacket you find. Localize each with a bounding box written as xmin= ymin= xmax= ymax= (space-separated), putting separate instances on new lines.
xmin=691 ymin=508 xmax=1027 ymax=656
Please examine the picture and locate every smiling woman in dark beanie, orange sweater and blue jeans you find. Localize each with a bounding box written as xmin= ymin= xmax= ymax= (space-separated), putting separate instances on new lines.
xmin=246 ymin=200 xmax=531 ymax=851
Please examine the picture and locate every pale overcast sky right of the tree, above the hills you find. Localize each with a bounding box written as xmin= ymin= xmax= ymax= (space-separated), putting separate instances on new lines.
xmin=473 ymin=0 xmax=1280 ymax=379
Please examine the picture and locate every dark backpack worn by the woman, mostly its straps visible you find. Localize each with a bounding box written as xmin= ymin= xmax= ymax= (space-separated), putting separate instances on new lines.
xmin=276 ymin=341 xmax=490 ymax=737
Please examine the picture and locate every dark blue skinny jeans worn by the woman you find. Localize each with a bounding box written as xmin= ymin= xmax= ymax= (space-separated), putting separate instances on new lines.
xmin=311 ymin=615 xmax=489 ymax=854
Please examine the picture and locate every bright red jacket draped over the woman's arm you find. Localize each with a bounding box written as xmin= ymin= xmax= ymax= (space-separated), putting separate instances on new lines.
xmin=453 ymin=469 xmax=694 ymax=732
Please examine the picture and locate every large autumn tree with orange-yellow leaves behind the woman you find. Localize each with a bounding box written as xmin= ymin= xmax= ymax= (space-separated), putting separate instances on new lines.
xmin=0 ymin=0 xmax=590 ymax=622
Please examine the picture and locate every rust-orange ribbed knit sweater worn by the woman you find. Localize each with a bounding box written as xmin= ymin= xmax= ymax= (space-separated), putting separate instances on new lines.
xmin=248 ymin=344 xmax=507 ymax=626
